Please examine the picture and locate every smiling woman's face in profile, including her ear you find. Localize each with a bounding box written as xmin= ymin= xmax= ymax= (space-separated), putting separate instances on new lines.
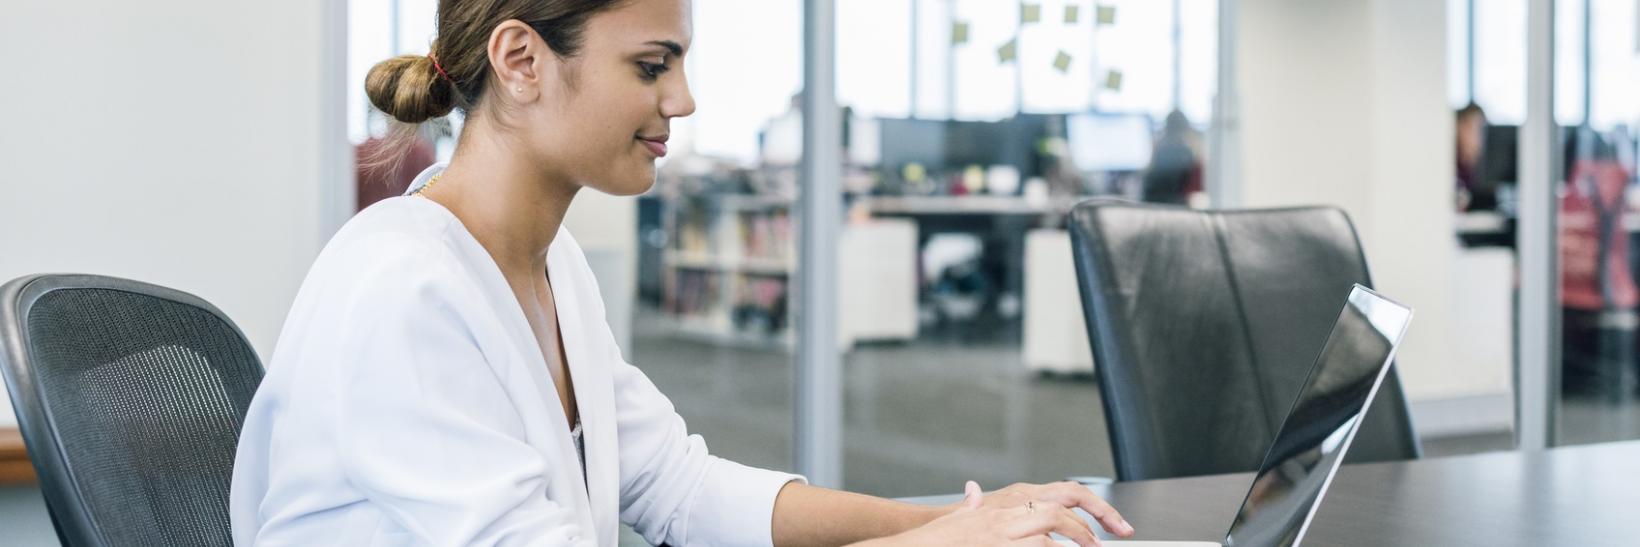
xmin=503 ymin=0 xmax=695 ymax=195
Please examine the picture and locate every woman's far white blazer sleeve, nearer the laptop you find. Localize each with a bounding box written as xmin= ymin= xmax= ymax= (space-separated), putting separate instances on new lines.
xmin=560 ymin=235 xmax=804 ymax=547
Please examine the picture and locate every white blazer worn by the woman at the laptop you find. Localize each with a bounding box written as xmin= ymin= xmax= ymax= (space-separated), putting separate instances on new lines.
xmin=230 ymin=165 xmax=802 ymax=547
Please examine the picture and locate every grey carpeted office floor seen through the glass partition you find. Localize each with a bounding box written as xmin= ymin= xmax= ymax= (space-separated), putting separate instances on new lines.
xmin=633 ymin=330 xmax=1112 ymax=496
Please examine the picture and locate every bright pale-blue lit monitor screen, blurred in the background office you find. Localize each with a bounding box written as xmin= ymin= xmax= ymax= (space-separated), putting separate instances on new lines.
xmin=1066 ymin=113 xmax=1156 ymax=172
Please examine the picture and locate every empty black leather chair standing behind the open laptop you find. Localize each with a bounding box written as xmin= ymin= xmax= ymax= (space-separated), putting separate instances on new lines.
xmin=1069 ymin=200 xmax=1420 ymax=480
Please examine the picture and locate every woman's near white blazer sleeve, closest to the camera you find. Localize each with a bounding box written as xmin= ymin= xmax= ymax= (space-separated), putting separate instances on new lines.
xmin=331 ymin=239 xmax=590 ymax=545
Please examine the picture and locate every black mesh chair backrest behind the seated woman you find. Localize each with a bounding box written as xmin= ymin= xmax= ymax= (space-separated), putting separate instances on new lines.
xmin=0 ymin=275 xmax=262 ymax=545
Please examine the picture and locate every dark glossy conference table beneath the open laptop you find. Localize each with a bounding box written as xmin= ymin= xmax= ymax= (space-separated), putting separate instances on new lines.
xmin=907 ymin=442 xmax=1640 ymax=545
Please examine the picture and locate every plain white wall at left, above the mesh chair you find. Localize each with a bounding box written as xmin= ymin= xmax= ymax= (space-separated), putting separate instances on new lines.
xmin=0 ymin=0 xmax=353 ymax=419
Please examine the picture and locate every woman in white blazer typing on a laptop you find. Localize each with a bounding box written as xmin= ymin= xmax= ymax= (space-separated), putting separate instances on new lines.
xmin=230 ymin=0 xmax=1132 ymax=545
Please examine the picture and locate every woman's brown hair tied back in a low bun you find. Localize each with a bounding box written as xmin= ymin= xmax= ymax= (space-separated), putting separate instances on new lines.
xmin=364 ymin=0 xmax=623 ymax=124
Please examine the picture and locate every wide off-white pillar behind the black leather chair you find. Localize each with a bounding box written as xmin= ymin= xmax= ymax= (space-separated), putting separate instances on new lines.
xmin=1235 ymin=0 xmax=1512 ymax=412
